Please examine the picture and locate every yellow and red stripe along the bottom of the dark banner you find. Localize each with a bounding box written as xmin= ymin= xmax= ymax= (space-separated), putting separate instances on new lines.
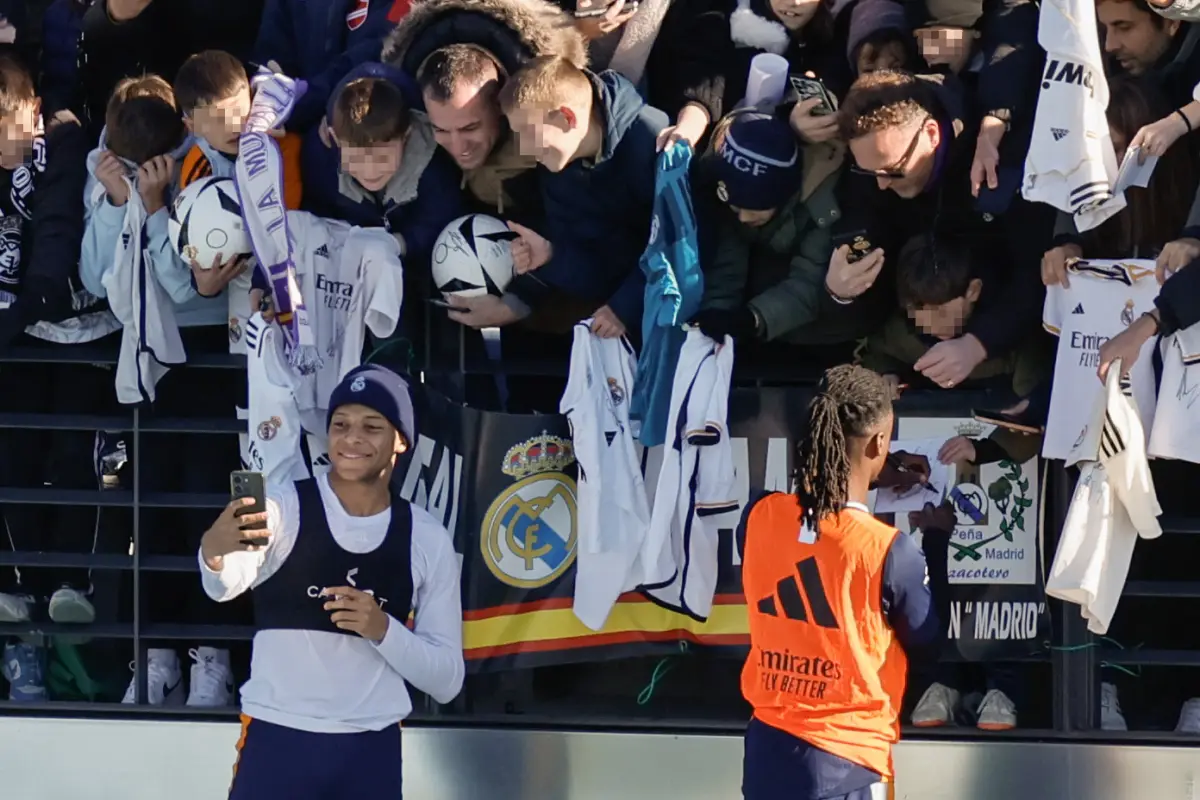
xmin=462 ymin=593 xmax=750 ymax=661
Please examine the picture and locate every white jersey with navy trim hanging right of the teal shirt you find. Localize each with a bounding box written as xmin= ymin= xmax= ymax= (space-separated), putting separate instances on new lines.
xmin=642 ymin=329 xmax=739 ymax=620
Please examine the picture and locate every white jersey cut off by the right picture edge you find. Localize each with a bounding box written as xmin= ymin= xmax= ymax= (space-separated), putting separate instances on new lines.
xmin=1148 ymin=325 xmax=1200 ymax=463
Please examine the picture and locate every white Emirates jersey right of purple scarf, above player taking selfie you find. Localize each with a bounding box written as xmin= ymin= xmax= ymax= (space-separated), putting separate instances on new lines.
xmin=288 ymin=211 xmax=403 ymax=435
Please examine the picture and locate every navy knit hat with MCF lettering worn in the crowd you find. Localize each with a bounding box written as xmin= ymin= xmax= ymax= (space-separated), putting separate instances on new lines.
xmin=708 ymin=109 xmax=803 ymax=211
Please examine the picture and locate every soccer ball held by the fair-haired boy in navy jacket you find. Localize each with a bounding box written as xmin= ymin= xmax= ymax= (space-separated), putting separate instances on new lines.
xmin=433 ymin=213 xmax=517 ymax=297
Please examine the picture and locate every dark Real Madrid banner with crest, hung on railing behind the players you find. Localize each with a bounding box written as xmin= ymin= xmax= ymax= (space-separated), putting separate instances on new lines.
xmin=395 ymin=385 xmax=1049 ymax=672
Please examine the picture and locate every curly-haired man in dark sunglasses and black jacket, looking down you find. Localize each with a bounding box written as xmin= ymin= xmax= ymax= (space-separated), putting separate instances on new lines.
xmin=827 ymin=71 xmax=1054 ymax=387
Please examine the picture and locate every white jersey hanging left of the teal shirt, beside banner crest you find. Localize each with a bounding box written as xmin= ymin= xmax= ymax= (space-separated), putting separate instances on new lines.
xmin=559 ymin=320 xmax=650 ymax=631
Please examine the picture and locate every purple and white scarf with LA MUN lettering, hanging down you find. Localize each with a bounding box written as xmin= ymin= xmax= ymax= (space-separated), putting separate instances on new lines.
xmin=236 ymin=70 xmax=322 ymax=375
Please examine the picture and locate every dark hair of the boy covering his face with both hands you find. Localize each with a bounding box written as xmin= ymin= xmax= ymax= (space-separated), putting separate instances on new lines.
xmin=104 ymin=76 xmax=187 ymax=164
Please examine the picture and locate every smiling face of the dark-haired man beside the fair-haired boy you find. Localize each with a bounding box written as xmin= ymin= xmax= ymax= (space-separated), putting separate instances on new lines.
xmin=425 ymin=74 xmax=504 ymax=169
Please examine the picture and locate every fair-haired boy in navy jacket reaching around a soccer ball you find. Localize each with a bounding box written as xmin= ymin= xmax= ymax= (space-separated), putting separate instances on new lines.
xmin=450 ymin=55 xmax=670 ymax=337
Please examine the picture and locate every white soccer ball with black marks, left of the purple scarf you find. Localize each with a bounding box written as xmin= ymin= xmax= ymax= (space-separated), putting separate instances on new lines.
xmin=167 ymin=176 xmax=254 ymax=270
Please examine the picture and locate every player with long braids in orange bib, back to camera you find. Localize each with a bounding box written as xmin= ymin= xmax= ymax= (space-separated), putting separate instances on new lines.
xmin=739 ymin=366 xmax=953 ymax=800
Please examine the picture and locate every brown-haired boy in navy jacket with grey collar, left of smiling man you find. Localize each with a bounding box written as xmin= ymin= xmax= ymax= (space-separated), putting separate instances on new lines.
xmin=308 ymin=65 xmax=462 ymax=267
